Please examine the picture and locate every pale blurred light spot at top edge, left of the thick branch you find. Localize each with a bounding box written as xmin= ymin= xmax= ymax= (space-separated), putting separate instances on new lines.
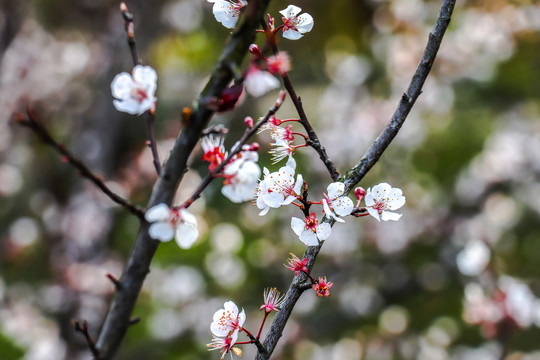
xmin=161 ymin=0 xmax=202 ymax=32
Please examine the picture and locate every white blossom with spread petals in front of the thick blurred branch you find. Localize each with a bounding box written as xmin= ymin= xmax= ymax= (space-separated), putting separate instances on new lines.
xmin=144 ymin=203 xmax=199 ymax=249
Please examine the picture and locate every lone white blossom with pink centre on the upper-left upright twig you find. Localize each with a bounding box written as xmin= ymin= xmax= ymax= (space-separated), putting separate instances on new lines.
xmin=111 ymin=65 xmax=157 ymax=115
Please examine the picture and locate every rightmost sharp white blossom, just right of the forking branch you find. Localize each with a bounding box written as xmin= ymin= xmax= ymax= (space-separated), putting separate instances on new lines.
xmin=365 ymin=183 xmax=405 ymax=221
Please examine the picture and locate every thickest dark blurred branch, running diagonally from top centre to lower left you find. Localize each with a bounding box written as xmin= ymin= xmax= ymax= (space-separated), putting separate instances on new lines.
xmin=97 ymin=0 xmax=270 ymax=360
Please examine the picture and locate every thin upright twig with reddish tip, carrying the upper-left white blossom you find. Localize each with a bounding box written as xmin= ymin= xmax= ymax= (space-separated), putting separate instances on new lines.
xmin=120 ymin=2 xmax=161 ymax=176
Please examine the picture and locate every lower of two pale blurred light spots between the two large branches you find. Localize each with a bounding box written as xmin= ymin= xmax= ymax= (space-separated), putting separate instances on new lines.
xmin=205 ymin=253 xmax=246 ymax=287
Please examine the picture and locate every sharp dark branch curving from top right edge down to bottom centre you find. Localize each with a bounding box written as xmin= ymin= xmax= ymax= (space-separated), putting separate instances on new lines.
xmin=256 ymin=0 xmax=456 ymax=360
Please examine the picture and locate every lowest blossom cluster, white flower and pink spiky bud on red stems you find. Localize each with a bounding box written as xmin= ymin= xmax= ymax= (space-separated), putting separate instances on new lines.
xmin=207 ymin=288 xmax=285 ymax=359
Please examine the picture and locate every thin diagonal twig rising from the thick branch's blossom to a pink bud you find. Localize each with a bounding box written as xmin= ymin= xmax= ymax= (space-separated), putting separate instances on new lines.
xmin=181 ymin=91 xmax=286 ymax=209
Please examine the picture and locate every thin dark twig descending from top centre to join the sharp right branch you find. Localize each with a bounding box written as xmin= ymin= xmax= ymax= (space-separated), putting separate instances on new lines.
xmin=261 ymin=20 xmax=340 ymax=181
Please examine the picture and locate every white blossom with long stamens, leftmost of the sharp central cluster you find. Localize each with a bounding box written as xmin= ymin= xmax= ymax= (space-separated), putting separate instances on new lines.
xmin=256 ymin=157 xmax=304 ymax=216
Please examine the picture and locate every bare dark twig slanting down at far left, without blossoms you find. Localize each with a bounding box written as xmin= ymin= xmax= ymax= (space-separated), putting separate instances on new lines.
xmin=15 ymin=108 xmax=144 ymax=219
